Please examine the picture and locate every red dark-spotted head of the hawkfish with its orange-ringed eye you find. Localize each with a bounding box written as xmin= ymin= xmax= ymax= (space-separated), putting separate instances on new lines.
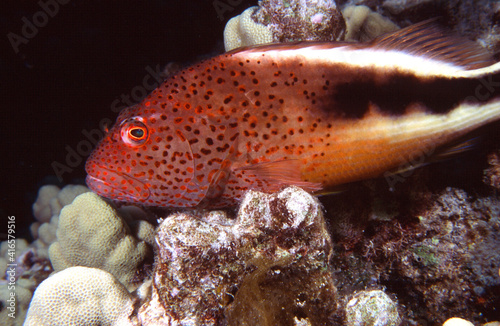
xmin=85 ymin=107 xmax=196 ymax=207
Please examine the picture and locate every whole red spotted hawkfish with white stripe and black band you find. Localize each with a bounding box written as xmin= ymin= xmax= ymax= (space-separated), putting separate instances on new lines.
xmin=86 ymin=22 xmax=500 ymax=208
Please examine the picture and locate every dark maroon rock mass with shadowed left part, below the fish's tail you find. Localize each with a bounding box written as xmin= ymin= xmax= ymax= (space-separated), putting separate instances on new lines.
xmin=325 ymin=178 xmax=500 ymax=325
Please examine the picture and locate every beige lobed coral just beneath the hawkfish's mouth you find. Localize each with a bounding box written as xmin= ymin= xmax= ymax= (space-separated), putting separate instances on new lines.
xmin=49 ymin=193 xmax=154 ymax=289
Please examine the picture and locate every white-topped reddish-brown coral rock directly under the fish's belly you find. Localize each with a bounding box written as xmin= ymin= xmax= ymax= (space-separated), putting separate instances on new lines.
xmin=134 ymin=187 xmax=336 ymax=325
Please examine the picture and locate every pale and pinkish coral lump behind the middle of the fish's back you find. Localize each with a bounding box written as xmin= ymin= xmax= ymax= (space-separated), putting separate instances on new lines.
xmin=224 ymin=0 xmax=345 ymax=51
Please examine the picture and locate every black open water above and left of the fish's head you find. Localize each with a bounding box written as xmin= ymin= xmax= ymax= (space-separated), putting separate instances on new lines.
xmin=0 ymin=0 xmax=257 ymax=240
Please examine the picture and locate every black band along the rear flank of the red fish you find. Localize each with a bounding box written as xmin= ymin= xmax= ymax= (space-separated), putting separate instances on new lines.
xmin=324 ymin=67 xmax=500 ymax=119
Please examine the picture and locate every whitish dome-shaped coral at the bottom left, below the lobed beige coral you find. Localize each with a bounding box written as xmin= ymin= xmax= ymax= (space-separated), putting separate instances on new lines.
xmin=24 ymin=266 xmax=131 ymax=326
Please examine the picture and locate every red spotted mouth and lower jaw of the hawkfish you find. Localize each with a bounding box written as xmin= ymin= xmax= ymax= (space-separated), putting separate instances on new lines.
xmin=85 ymin=165 xmax=151 ymax=203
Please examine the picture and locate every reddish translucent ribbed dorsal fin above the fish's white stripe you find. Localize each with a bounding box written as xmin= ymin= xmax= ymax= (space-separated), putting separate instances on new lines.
xmin=371 ymin=19 xmax=495 ymax=70
